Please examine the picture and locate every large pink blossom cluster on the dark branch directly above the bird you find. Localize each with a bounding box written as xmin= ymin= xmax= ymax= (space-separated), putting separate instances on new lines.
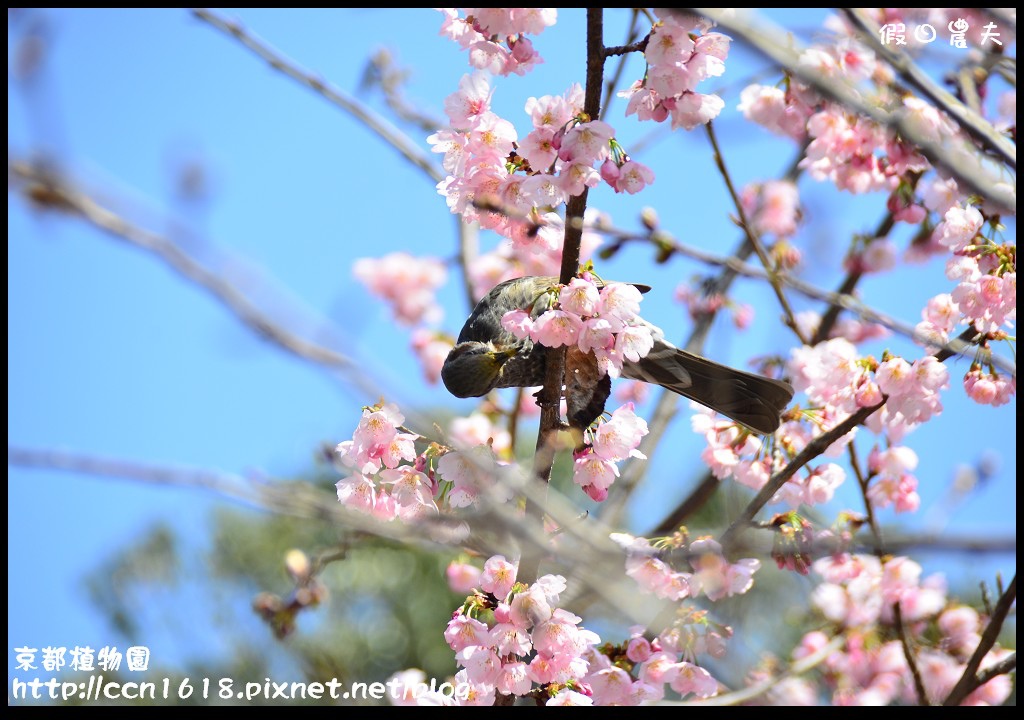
xmin=427 ymin=73 xmax=654 ymax=247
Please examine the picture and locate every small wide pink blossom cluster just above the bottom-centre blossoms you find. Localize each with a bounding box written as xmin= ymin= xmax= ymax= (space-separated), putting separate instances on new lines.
xmin=611 ymin=533 xmax=761 ymax=601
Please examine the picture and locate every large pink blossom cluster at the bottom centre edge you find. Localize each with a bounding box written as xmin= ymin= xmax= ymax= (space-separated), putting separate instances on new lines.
xmin=428 ymin=555 xmax=732 ymax=706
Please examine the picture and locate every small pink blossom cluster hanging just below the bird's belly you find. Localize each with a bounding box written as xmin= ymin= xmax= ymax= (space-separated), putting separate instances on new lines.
xmin=572 ymin=403 xmax=647 ymax=503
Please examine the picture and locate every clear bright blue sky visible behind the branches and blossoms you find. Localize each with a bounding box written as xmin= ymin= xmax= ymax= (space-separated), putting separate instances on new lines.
xmin=7 ymin=9 xmax=1016 ymax=688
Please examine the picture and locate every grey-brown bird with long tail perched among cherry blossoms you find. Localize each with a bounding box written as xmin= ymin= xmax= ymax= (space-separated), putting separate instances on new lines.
xmin=441 ymin=277 xmax=793 ymax=433
